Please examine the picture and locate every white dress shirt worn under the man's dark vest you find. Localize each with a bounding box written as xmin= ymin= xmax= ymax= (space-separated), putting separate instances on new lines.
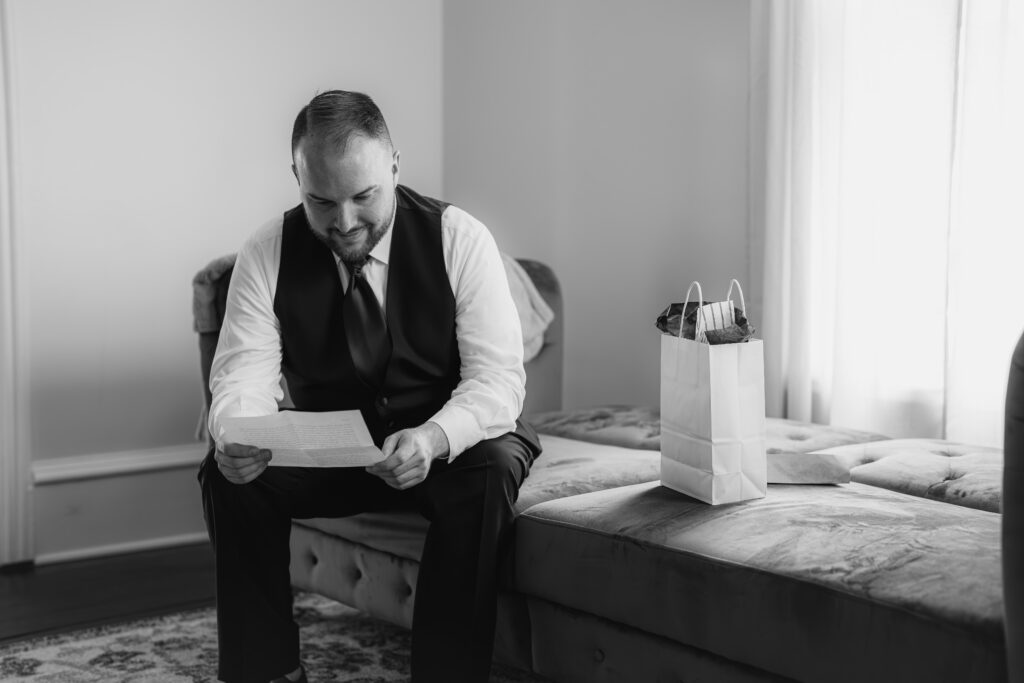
xmin=209 ymin=206 xmax=526 ymax=459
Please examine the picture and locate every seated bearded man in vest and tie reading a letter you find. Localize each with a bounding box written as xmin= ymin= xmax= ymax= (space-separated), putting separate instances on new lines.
xmin=194 ymin=91 xmax=540 ymax=683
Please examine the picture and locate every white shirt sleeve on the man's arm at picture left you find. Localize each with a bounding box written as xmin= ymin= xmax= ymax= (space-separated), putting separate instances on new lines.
xmin=209 ymin=219 xmax=284 ymax=446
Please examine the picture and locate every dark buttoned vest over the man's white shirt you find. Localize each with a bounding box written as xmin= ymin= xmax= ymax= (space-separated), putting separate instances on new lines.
xmin=273 ymin=185 xmax=460 ymax=444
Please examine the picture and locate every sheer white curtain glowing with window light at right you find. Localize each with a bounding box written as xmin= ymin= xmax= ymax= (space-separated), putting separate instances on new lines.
xmin=763 ymin=0 xmax=1024 ymax=444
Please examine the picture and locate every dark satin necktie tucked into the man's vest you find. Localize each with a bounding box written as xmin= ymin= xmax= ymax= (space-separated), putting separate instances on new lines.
xmin=341 ymin=261 xmax=391 ymax=389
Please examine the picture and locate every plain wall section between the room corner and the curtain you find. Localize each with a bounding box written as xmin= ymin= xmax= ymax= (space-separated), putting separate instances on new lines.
xmin=444 ymin=0 xmax=760 ymax=407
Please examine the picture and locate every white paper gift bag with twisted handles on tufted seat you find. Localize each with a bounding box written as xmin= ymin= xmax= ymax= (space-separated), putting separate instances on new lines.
xmin=662 ymin=280 xmax=768 ymax=505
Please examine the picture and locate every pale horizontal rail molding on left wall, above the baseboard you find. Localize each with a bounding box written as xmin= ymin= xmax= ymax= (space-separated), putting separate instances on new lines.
xmin=32 ymin=443 xmax=207 ymax=486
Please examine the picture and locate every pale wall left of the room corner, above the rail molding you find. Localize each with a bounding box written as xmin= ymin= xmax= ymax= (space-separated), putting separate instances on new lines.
xmin=6 ymin=0 xmax=442 ymax=460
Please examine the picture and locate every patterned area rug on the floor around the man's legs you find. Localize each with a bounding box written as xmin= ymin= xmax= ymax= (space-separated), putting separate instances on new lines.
xmin=0 ymin=593 xmax=544 ymax=683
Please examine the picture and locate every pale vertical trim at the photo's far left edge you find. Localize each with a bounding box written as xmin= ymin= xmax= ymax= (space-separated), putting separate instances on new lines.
xmin=0 ymin=0 xmax=34 ymax=565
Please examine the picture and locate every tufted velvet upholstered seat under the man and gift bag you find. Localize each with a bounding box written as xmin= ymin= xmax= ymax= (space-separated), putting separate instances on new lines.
xmin=197 ymin=260 xmax=1007 ymax=683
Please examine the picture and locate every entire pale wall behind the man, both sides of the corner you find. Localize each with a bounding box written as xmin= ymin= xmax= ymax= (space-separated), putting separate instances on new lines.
xmin=0 ymin=0 xmax=750 ymax=557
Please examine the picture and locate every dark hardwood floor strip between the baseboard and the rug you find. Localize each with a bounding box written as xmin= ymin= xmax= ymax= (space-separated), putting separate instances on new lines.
xmin=0 ymin=544 xmax=214 ymax=644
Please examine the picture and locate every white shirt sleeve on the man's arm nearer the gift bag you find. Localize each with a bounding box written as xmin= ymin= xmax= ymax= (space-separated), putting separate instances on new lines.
xmin=431 ymin=206 xmax=526 ymax=460
